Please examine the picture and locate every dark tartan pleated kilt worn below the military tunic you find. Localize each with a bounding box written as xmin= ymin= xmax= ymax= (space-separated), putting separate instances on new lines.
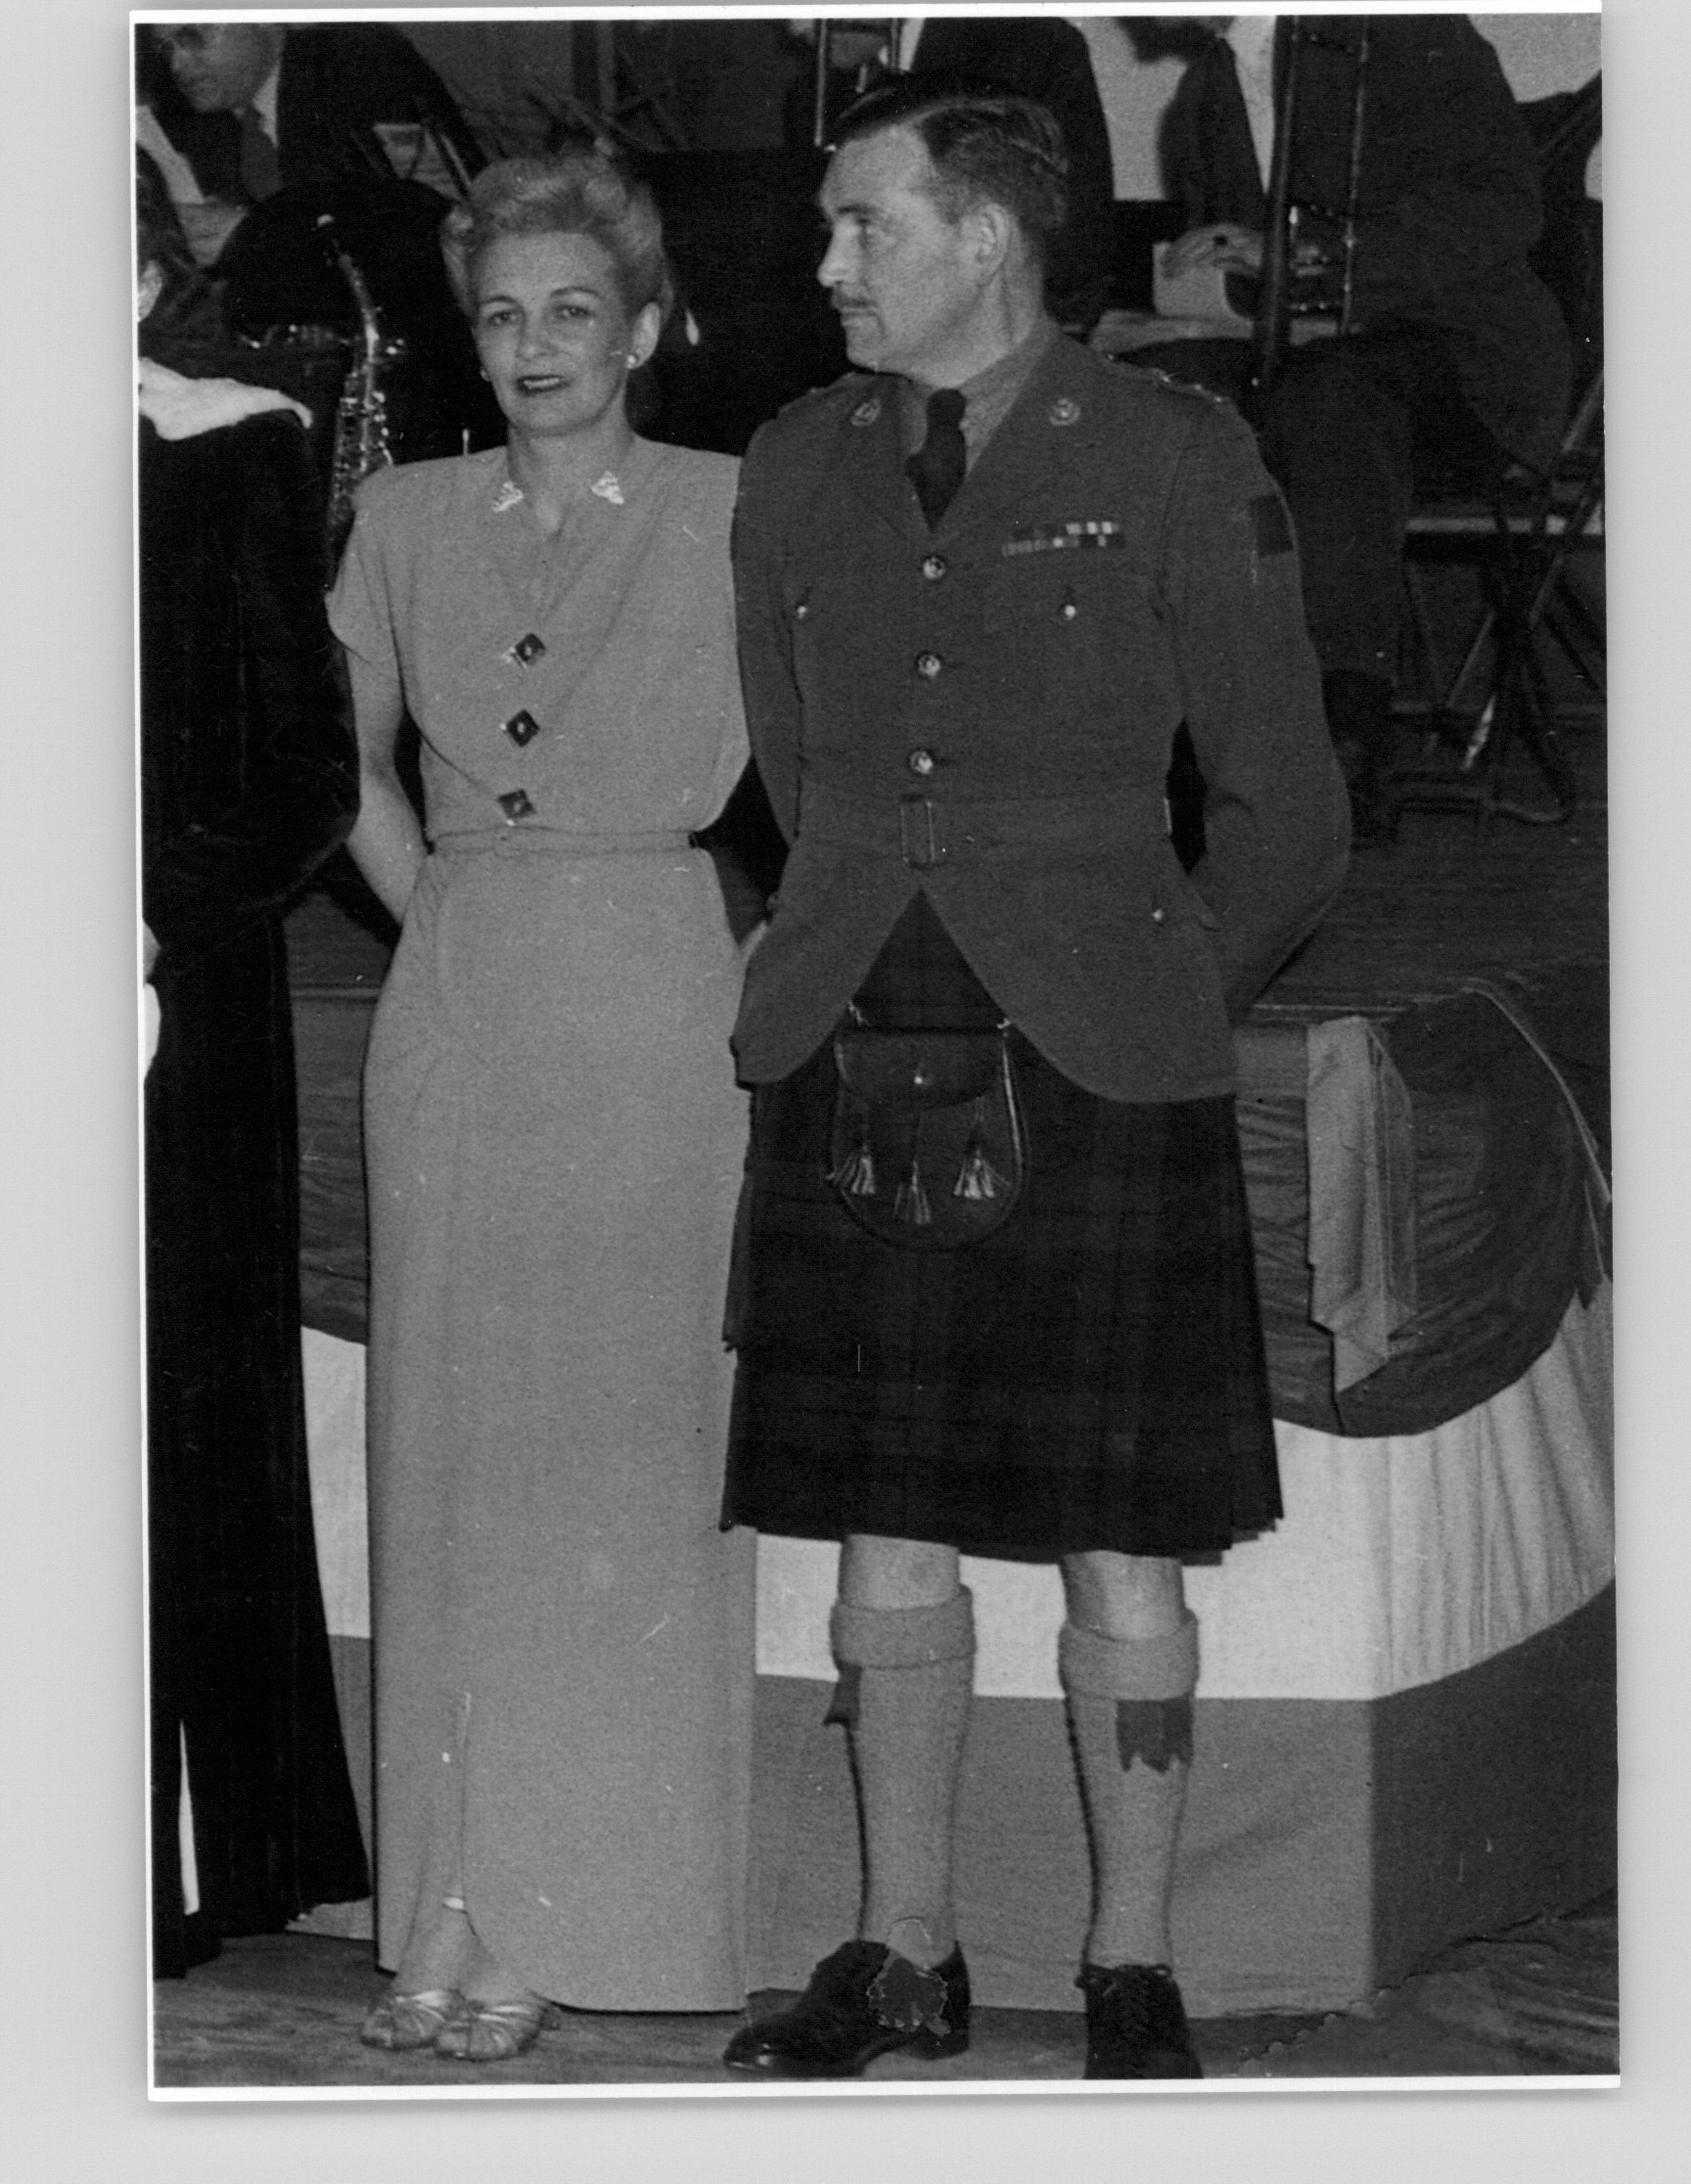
xmin=723 ymin=897 xmax=1280 ymax=1562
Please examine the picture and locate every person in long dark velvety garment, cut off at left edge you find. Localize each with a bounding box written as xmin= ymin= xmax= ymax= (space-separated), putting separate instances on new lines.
xmin=138 ymin=161 xmax=369 ymax=1977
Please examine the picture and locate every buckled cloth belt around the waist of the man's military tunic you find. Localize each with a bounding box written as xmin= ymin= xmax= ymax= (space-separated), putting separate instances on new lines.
xmin=800 ymin=780 xmax=1168 ymax=872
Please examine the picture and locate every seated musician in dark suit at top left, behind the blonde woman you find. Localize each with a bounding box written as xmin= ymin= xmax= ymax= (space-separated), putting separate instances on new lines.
xmin=138 ymin=20 xmax=494 ymax=459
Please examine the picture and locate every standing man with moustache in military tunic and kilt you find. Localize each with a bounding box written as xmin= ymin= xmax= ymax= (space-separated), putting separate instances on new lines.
xmin=725 ymin=78 xmax=1346 ymax=2077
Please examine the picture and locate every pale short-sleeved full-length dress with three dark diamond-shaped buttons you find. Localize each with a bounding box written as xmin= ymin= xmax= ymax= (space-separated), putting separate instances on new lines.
xmin=330 ymin=441 xmax=752 ymax=2009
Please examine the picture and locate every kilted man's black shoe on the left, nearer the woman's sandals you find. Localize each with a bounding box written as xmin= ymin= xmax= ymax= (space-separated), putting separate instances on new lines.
xmin=723 ymin=1941 xmax=970 ymax=2077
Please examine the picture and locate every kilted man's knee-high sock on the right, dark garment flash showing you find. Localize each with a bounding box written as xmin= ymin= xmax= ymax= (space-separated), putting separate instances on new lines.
xmin=1058 ymin=1614 xmax=1197 ymax=1966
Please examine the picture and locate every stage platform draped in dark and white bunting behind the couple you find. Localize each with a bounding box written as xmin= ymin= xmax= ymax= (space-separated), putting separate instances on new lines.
xmin=291 ymin=738 xmax=1615 ymax=2016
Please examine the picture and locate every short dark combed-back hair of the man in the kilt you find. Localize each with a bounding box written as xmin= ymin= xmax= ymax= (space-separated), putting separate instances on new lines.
xmin=833 ymin=74 xmax=1069 ymax=262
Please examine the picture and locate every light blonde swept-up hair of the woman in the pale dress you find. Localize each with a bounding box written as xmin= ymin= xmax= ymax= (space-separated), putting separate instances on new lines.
xmin=441 ymin=144 xmax=675 ymax=317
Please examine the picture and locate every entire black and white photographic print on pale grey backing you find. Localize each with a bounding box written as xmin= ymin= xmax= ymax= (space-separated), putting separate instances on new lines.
xmin=115 ymin=7 xmax=1638 ymax=2114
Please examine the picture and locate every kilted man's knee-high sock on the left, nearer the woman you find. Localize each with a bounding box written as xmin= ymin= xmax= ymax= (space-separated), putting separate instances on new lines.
xmin=833 ymin=1588 xmax=975 ymax=1964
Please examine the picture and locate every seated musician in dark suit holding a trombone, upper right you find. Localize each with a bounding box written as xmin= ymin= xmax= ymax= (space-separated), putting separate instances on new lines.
xmin=1134 ymin=16 xmax=1569 ymax=841
